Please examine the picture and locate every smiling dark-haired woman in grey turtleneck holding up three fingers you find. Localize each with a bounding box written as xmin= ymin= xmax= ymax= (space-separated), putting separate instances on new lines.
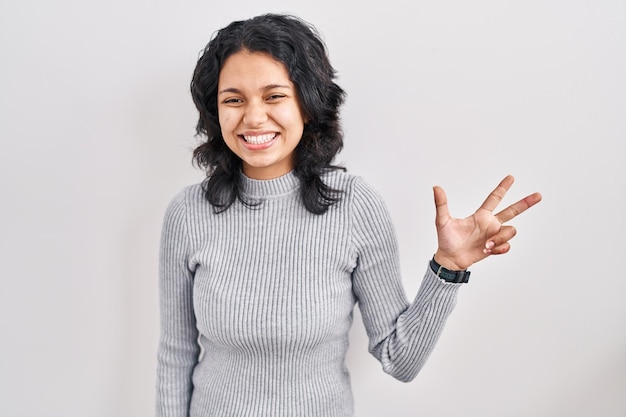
xmin=157 ymin=15 xmax=541 ymax=417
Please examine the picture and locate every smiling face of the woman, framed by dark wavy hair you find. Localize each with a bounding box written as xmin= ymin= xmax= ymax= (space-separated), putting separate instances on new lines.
xmin=217 ymin=50 xmax=304 ymax=180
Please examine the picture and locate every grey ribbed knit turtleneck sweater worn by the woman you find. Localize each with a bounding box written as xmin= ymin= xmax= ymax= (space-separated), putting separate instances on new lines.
xmin=157 ymin=171 xmax=459 ymax=417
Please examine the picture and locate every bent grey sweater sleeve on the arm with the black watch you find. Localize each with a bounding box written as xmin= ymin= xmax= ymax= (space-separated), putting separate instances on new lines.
xmin=352 ymin=179 xmax=460 ymax=382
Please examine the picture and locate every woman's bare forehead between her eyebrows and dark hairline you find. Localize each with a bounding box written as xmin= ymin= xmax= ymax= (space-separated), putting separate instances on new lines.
xmin=218 ymin=50 xmax=292 ymax=89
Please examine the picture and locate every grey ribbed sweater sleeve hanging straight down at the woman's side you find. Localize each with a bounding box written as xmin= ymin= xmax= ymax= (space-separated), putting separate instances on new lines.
xmin=156 ymin=191 xmax=200 ymax=417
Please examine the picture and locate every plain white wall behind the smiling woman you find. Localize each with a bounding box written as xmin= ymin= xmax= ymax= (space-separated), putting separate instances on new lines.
xmin=0 ymin=0 xmax=626 ymax=417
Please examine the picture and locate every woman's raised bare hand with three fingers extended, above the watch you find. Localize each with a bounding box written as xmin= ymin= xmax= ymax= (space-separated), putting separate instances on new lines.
xmin=433 ymin=175 xmax=541 ymax=270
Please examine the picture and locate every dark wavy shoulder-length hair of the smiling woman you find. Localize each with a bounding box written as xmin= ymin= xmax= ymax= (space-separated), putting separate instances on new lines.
xmin=191 ymin=14 xmax=345 ymax=214
